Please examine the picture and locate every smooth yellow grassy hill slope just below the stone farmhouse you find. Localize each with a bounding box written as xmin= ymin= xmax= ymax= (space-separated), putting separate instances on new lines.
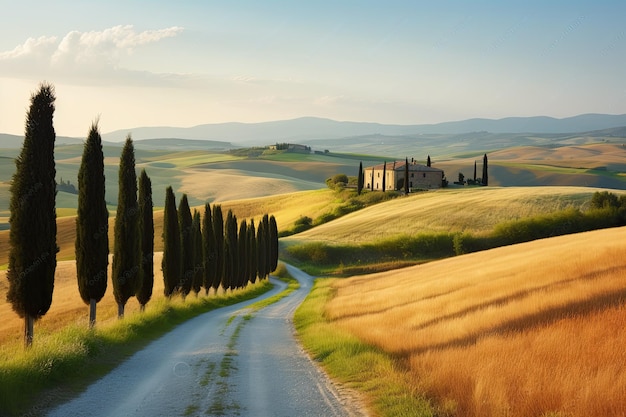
xmin=284 ymin=187 xmax=608 ymax=244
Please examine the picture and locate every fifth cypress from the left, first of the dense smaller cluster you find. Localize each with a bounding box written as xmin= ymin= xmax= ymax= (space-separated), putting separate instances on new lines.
xmin=161 ymin=186 xmax=182 ymax=297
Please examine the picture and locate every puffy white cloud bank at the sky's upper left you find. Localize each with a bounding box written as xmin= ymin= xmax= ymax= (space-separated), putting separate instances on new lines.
xmin=0 ymin=25 xmax=183 ymax=82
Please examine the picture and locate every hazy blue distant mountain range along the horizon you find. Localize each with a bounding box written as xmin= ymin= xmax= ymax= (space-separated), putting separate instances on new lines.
xmin=0 ymin=114 xmax=626 ymax=149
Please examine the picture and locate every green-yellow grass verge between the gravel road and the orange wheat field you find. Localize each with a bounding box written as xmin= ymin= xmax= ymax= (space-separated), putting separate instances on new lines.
xmin=294 ymin=279 xmax=436 ymax=417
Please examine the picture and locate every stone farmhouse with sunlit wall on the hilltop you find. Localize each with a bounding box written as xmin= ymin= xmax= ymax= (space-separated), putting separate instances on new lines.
xmin=363 ymin=161 xmax=444 ymax=191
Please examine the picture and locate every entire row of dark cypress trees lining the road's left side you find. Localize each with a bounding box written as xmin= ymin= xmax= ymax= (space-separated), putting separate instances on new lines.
xmin=7 ymin=83 xmax=278 ymax=347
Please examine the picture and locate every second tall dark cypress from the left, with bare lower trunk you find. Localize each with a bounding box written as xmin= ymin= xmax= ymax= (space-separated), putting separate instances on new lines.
xmin=74 ymin=121 xmax=109 ymax=327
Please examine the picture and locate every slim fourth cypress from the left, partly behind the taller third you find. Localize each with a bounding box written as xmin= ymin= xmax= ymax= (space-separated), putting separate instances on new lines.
xmin=135 ymin=169 xmax=154 ymax=311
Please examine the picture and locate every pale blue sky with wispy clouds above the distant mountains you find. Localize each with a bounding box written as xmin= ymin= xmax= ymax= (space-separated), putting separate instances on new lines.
xmin=0 ymin=0 xmax=626 ymax=140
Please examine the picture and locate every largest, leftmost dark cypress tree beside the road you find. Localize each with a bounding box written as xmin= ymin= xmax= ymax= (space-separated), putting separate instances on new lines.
xmin=7 ymin=83 xmax=58 ymax=346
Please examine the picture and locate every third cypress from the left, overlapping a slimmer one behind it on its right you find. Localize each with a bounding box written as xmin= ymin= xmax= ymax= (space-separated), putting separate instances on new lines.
xmin=111 ymin=135 xmax=141 ymax=318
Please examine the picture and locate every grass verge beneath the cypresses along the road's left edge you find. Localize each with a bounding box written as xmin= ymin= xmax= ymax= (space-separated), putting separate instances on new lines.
xmin=0 ymin=280 xmax=272 ymax=416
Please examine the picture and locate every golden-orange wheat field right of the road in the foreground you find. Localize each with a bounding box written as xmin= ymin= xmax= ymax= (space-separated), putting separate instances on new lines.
xmin=326 ymin=228 xmax=626 ymax=417
